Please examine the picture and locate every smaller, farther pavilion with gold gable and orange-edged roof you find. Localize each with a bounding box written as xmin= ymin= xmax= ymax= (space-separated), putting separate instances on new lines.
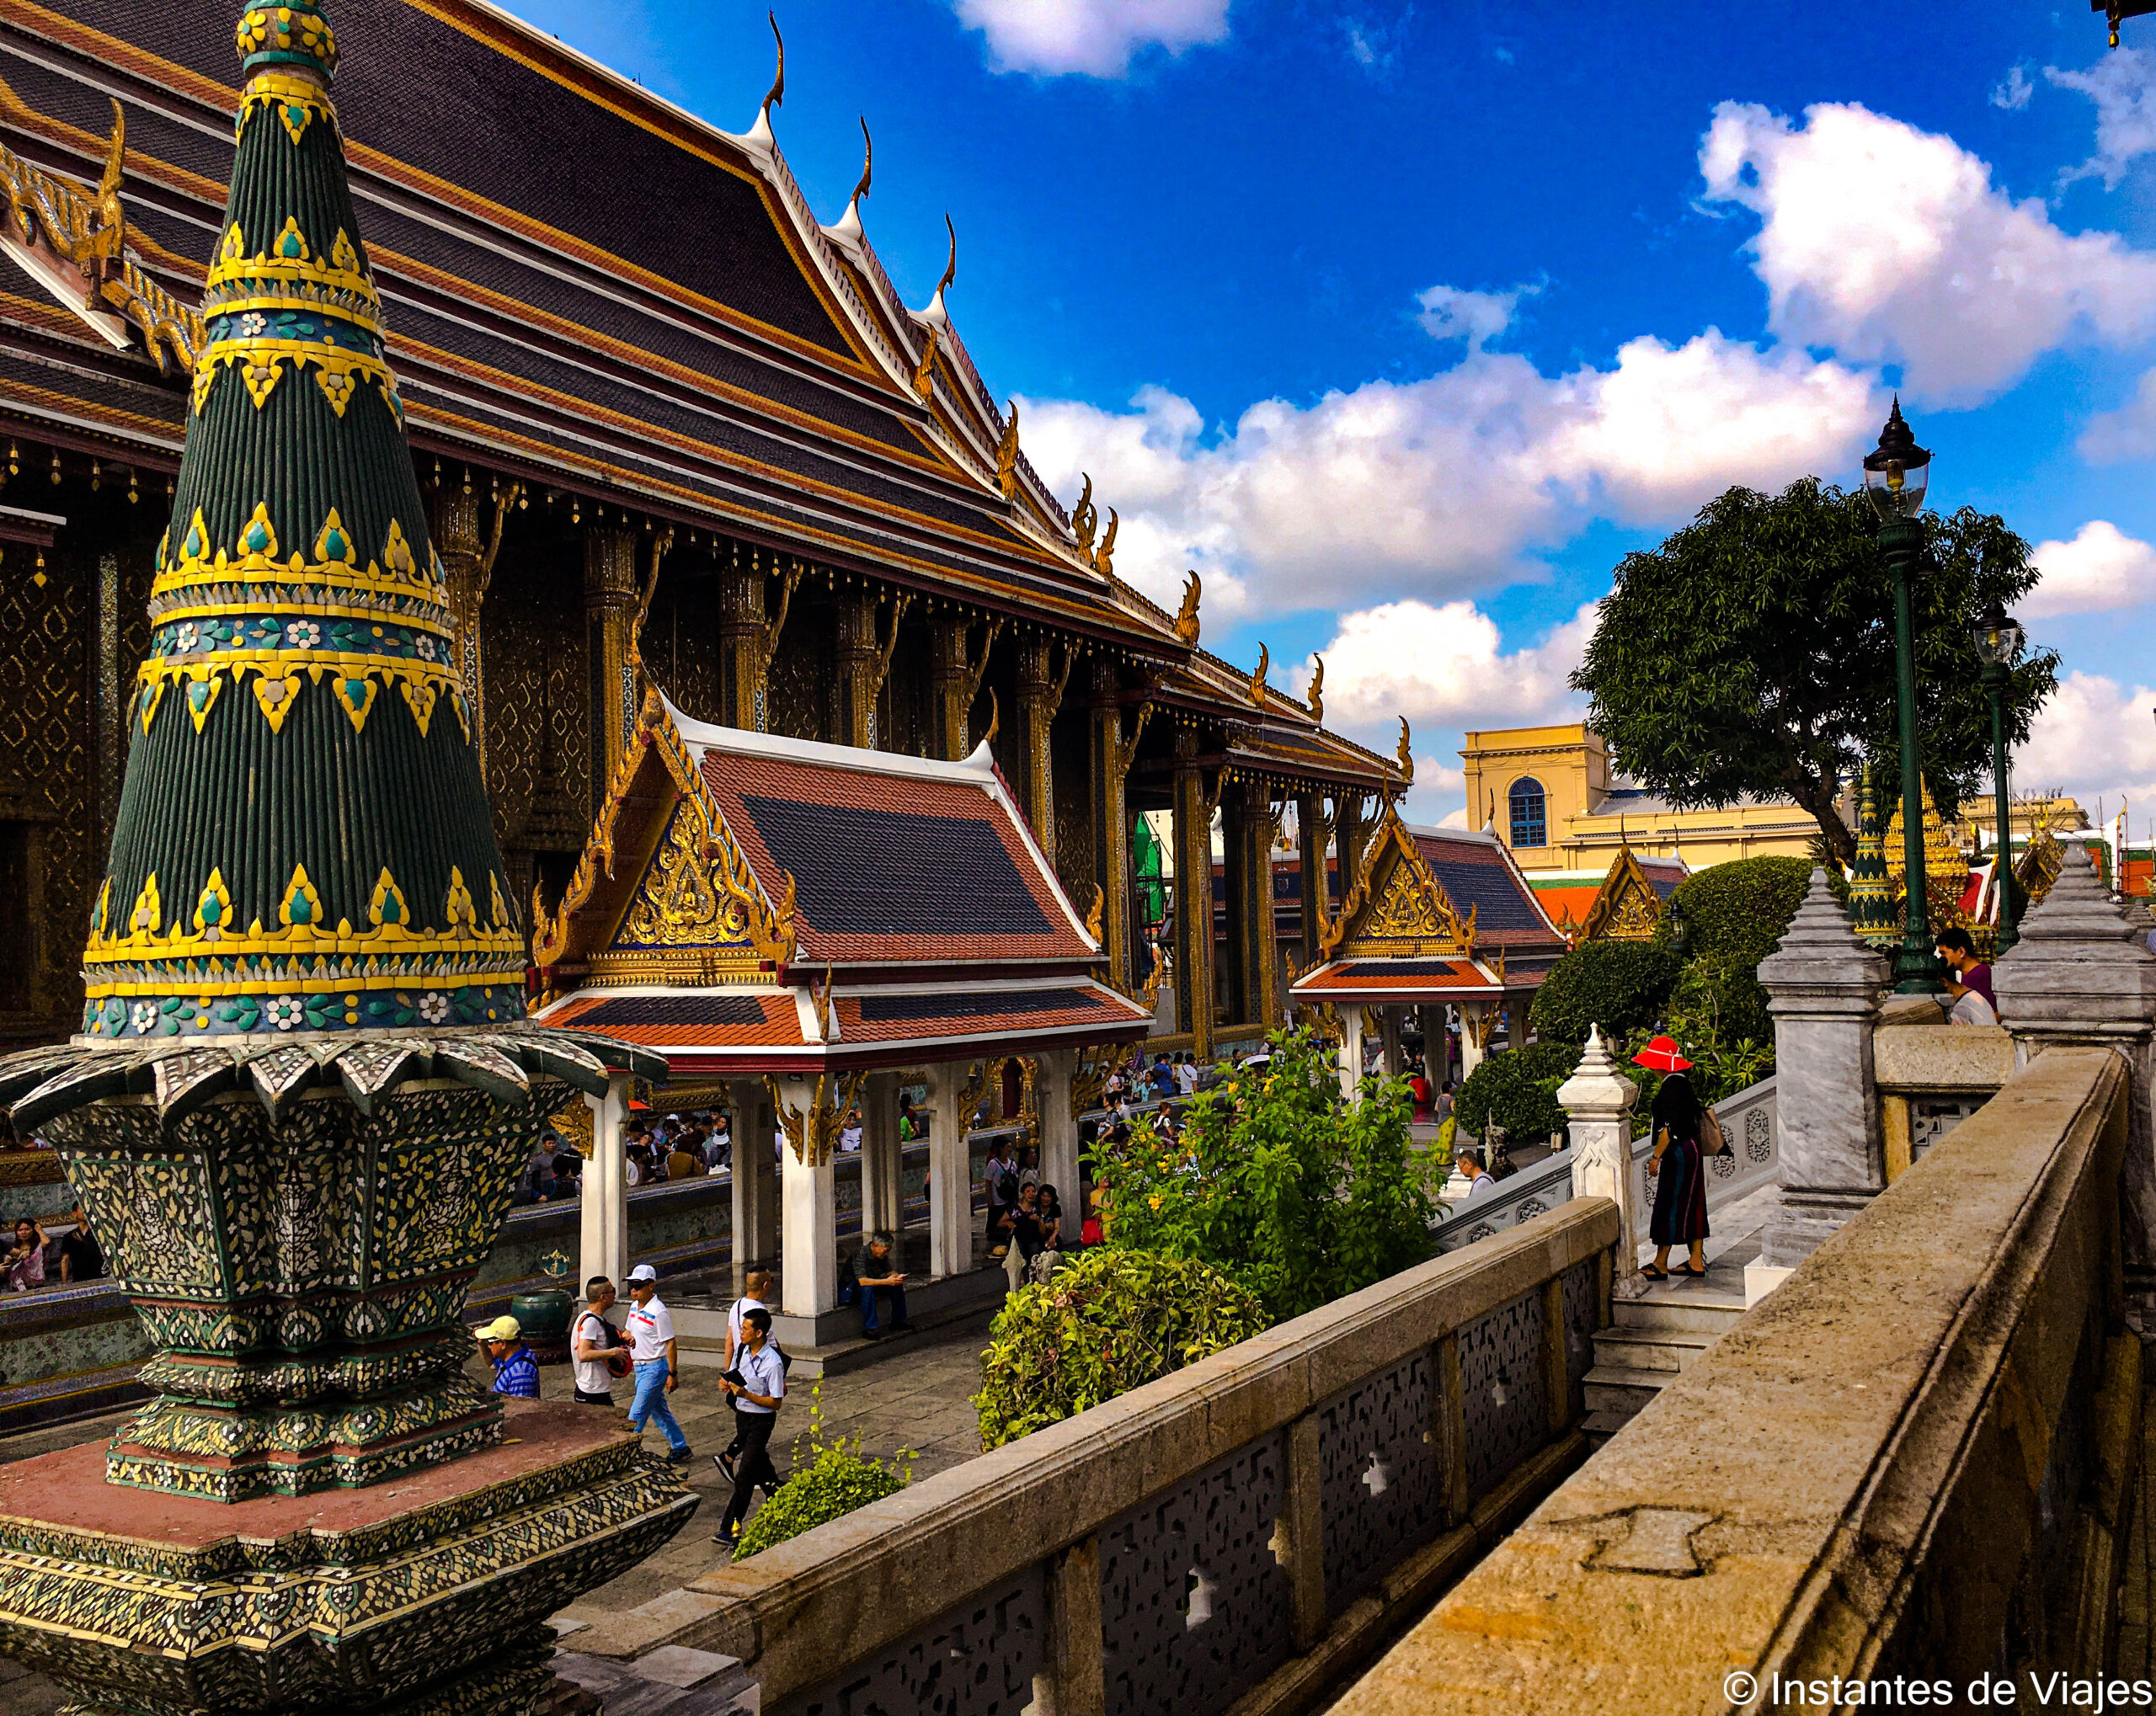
xmin=1289 ymin=807 xmax=1566 ymax=1093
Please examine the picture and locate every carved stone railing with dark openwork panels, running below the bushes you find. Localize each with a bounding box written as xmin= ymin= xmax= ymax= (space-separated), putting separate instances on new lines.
xmin=629 ymin=1199 xmax=1617 ymax=1716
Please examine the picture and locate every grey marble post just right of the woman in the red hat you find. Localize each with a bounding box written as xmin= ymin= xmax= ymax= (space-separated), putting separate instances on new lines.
xmin=1759 ymin=869 xmax=1891 ymax=1270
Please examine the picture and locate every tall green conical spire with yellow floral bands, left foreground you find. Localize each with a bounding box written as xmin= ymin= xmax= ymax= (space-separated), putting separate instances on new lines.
xmin=84 ymin=0 xmax=524 ymax=1039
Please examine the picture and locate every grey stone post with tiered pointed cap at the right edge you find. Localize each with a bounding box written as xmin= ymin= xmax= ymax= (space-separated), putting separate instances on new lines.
xmin=1992 ymin=841 xmax=2156 ymax=1332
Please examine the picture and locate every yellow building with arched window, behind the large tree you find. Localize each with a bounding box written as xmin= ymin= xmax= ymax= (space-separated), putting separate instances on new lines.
xmin=1460 ymin=722 xmax=1856 ymax=871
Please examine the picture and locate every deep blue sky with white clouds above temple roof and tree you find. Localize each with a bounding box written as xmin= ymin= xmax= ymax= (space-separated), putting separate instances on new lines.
xmin=511 ymin=0 xmax=2156 ymax=823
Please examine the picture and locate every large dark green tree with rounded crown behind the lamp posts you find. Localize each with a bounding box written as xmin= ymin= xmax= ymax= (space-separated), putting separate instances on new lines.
xmin=1572 ymin=477 xmax=2059 ymax=865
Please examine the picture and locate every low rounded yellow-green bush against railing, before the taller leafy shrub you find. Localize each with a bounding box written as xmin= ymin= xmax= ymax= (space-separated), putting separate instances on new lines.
xmin=974 ymin=1246 xmax=1267 ymax=1448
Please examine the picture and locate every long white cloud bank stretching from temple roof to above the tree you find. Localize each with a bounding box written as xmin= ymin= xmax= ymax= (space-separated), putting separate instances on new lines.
xmin=1022 ymin=328 xmax=1882 ymax=616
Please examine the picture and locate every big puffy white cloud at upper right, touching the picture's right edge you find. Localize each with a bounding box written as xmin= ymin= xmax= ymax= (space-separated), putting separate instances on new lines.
xmin=1699 ymin=101 xmax=2156 ymax=403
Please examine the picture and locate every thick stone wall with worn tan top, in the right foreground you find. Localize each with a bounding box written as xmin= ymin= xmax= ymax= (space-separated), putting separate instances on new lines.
xmin=1335 ymin=1046 xmax=2141 ymax=1716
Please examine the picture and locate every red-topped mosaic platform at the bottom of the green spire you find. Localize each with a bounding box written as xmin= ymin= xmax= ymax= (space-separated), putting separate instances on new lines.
xmin=0 ymin=1401 xmax=696 ymax=1716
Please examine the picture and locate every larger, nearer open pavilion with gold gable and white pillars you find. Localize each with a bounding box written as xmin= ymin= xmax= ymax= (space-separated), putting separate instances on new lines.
xmin=532 ymin=690 xmax=1151 ymax=1319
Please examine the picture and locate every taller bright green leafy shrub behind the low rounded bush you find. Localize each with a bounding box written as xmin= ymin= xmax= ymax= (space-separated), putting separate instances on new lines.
xmin=1093 ymin=1031 xmax=1436 ymax=1321
